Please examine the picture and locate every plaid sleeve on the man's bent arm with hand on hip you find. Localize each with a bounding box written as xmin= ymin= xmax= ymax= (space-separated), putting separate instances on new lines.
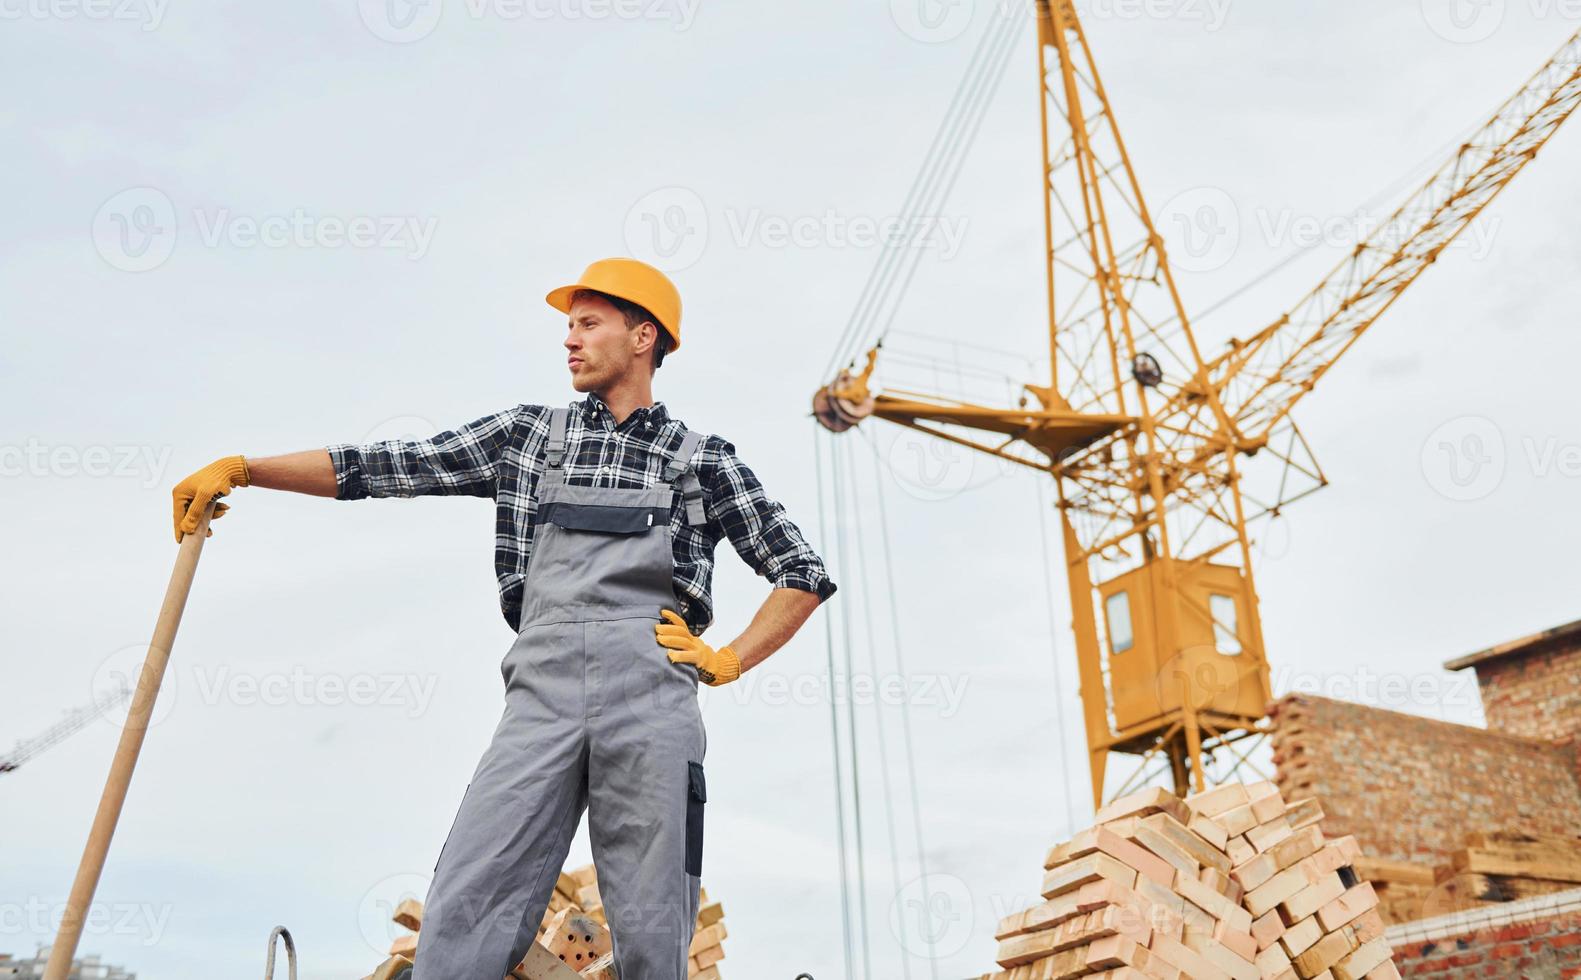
xmin=704 ymin=436 xmax=836 ymax=602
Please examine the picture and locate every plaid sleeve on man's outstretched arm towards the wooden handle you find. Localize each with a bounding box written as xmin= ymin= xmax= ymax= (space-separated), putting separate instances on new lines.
xmin=326 ymin=408 xmax=519 ymax=499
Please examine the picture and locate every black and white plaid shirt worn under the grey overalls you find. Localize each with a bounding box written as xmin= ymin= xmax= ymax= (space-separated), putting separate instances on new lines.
xmin=327 ymin=394 xmax=835 ymax=634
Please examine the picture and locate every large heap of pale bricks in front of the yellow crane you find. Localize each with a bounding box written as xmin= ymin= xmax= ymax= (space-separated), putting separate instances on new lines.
xmin=983 ymin=782 xmax=1399 ymax=980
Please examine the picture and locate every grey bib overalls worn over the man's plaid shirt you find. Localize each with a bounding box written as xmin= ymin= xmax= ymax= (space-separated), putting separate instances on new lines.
xmin=413 ymin=408 xmax=707 ymax=980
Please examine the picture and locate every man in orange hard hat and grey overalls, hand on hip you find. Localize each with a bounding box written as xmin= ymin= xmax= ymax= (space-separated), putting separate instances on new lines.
xmin=174 ymin=258 xmax=835 ymax=980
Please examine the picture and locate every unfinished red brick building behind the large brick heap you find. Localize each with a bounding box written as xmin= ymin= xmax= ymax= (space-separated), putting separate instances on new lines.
xmin=1270 ymin=621 xmax=1581 ymax=977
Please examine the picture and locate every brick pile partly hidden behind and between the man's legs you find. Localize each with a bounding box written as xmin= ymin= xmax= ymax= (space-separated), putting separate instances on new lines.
xmin=364 ymin=865 xmax=726 ymax=980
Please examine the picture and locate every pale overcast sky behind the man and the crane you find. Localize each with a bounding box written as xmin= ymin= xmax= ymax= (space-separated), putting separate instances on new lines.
xmin=0 ymin=0 xmax=1581 ymax=980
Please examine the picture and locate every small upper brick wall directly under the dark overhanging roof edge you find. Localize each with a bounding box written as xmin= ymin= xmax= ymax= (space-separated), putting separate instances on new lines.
xmin=1477 ymin=637 xmax=1581 ymax=738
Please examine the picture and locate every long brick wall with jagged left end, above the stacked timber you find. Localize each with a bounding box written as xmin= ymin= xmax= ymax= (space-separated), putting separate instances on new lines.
xmin=1270 ymin=694 xmax=1581 ymax=865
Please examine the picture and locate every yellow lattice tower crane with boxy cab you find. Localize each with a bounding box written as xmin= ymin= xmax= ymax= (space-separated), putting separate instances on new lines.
xmin=813 ymin=0 xmax=1581 ymax=806
